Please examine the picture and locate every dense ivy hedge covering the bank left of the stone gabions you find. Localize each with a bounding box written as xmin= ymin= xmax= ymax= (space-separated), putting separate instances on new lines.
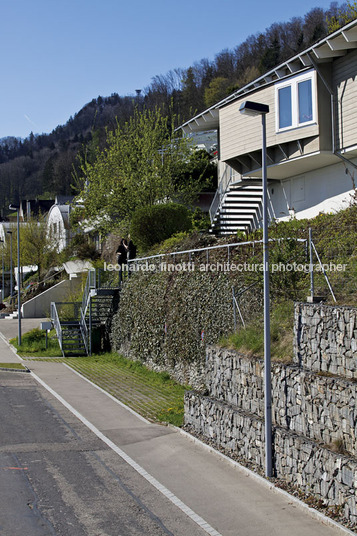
xmin=111 ymin=262 xmax=261 ymax=388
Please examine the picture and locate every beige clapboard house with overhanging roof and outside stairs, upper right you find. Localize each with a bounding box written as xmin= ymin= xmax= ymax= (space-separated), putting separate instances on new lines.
xmin=181 ymin=21 xmax=357 ymax=234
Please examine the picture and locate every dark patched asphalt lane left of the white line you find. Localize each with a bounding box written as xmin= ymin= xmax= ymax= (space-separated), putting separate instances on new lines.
xmin=0 ymin=372 xmax=205 ymax=536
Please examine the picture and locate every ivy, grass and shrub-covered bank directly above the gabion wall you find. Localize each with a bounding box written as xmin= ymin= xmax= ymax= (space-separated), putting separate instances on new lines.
xmin=112 ymin=203 xmax=357 ymax=378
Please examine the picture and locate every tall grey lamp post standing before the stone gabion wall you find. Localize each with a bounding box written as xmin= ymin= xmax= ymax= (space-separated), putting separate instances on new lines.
xmin=239 ymin=101 xmax=273 ymax=477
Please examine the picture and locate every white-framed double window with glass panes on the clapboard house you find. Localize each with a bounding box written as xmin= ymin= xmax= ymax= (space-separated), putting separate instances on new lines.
xmin=275 ymin=71 xmax=316 ymax=131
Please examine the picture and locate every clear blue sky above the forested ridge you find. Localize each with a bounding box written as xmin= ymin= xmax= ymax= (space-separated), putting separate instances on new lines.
xmin=0 ymin=0 xmax=334 ymax=138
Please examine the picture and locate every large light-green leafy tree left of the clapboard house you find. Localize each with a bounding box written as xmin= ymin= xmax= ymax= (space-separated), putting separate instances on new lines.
xmin=74 ymin=109 xmax=194 ymax=232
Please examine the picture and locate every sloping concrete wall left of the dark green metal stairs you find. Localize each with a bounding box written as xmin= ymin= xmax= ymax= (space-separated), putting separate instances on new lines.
xmin=21 ymin=277 xmax=82 ymax=318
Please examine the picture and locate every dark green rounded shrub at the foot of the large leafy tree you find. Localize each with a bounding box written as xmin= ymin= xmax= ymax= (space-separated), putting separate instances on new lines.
xmin=130 ymin=203 xmax=192 ymax=251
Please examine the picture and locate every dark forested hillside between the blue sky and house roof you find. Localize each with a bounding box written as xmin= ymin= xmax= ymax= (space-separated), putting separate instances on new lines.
xmin=0 ymin=2 xmax=354 ymax=217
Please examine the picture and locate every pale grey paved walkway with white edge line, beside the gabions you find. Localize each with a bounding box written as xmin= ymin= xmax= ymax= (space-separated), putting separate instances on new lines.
xmin=0 ymin=319 xmax=352 ymax=536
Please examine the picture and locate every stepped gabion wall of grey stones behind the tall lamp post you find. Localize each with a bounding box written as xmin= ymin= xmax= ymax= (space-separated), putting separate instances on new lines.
xmin=185 ymin=304 xmax=357 ymax=523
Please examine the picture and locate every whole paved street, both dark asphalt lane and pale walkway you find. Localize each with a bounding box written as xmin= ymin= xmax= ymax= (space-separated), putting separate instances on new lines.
xmin=0 ymin=321 xmax=353 ymax=536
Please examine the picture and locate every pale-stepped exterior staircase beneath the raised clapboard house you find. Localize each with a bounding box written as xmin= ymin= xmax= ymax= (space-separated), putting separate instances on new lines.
xmin=211 ymin=180 xmax=263 ymax=235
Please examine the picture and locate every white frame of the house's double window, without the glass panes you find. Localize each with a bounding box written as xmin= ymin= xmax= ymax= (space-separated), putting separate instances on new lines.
xmin=275 ymin=70 xmax=317 ymax=132
